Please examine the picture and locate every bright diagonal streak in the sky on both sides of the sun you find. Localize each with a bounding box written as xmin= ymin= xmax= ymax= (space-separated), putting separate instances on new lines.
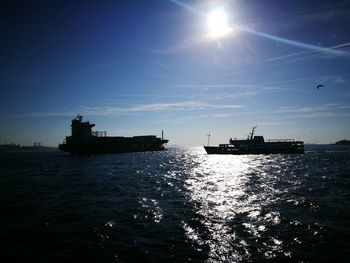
xmin=169 ymin=0 xmax=350 ymax=57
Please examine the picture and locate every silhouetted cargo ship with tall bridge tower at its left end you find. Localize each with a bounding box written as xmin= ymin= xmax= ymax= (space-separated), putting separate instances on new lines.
xmin=58 ymin=114 xmax=169 ymax=154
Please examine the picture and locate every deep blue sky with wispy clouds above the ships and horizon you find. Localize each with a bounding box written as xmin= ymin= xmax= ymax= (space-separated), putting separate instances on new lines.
xmin=0 ymin=0 xmax=350 ymax=146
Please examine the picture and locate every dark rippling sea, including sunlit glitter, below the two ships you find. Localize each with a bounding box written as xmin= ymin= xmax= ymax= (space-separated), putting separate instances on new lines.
xmin=0 ymin=146 xmax=350 ymax=262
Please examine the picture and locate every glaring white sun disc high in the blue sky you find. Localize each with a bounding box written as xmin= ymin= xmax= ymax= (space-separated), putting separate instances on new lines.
xmin=207 ymin=8 xmax=231 ymax=38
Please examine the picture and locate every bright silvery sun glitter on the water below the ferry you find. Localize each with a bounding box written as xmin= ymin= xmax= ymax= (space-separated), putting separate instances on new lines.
xmin=183 ymin=150 xmax=283 ymax=262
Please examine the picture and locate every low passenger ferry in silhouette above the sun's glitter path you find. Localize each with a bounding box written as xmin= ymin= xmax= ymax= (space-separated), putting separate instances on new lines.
xmin=204 ymin=127 xmax=304 ymax=154
